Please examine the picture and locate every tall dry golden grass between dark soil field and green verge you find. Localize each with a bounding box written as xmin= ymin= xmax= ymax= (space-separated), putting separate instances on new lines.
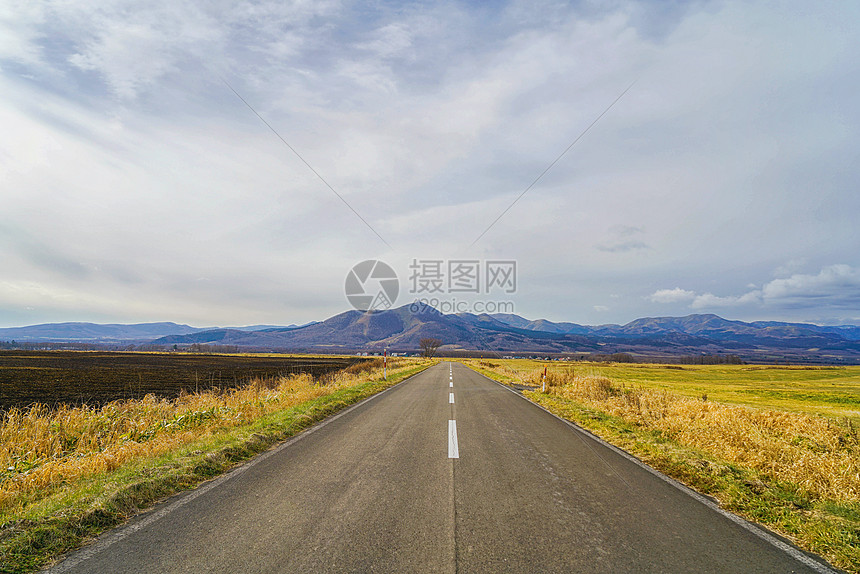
xmin=0 ymin=360 xmax=400 ymax=517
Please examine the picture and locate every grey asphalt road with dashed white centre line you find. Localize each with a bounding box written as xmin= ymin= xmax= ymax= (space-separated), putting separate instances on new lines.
xmin=48 ymin=363 xmax=830 ymax=574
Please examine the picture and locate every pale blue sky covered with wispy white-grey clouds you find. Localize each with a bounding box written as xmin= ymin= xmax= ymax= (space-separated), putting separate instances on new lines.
xmin=0 ymin=0 xmax=860 ymax=326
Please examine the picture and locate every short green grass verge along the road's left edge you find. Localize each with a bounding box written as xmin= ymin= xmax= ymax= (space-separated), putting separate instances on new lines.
xmin=0 ymin=364 xmax=428 ymax=574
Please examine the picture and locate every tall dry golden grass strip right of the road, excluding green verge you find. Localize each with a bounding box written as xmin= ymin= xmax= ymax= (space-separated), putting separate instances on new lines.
xmin=524 ymin=371 xmax=860 ymax=502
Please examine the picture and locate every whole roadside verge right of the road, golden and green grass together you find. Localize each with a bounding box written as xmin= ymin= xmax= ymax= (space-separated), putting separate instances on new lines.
xmin=470 ymin=362 xmax=860 ymax=572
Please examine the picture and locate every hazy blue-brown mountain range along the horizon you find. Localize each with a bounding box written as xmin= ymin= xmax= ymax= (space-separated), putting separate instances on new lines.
xmin=6 ymin=306 xmax=860 ymax=363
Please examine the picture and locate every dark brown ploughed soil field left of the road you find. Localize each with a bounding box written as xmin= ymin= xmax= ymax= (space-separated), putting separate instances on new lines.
xmin=0 ymin=351 xmax=362 ymax=411
